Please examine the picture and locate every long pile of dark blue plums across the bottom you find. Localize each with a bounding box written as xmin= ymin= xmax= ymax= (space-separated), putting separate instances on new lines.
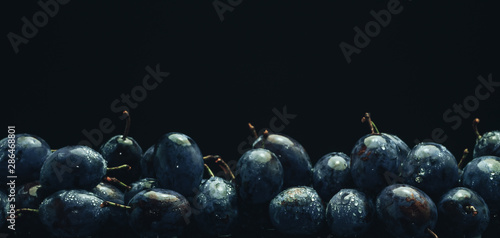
xmin=0 ymin=112 xmax=500 ymax=238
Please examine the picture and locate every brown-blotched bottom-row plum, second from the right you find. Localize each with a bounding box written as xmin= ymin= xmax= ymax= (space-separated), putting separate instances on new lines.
xmin=376 ymin=184 xmax=438 ymax=238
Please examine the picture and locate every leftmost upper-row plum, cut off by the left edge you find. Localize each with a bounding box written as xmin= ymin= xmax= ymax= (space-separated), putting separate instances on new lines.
xmin=0 ymin=133 xmax=51 ymax=185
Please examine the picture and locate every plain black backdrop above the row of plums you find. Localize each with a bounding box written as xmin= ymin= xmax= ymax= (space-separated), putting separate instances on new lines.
xmin=0 ymin=0 xmax=500 ymax=167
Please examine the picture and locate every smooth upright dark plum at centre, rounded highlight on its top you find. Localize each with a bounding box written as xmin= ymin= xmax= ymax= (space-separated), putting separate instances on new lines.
xmin=236 ymin=149 xmax=284 ymax=204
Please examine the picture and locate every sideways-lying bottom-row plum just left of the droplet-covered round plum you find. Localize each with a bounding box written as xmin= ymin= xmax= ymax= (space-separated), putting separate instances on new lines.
xmin=127 ymin=188 xmax=191 ymax=238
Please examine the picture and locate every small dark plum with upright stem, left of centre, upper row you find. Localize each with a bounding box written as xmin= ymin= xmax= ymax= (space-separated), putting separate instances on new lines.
xmin=99 ymin=111 xmax=143 ymax=184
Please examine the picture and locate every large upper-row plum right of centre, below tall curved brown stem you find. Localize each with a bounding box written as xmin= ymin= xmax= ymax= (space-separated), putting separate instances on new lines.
xmin=351 ymin=133 xmax=408 ymax=195
